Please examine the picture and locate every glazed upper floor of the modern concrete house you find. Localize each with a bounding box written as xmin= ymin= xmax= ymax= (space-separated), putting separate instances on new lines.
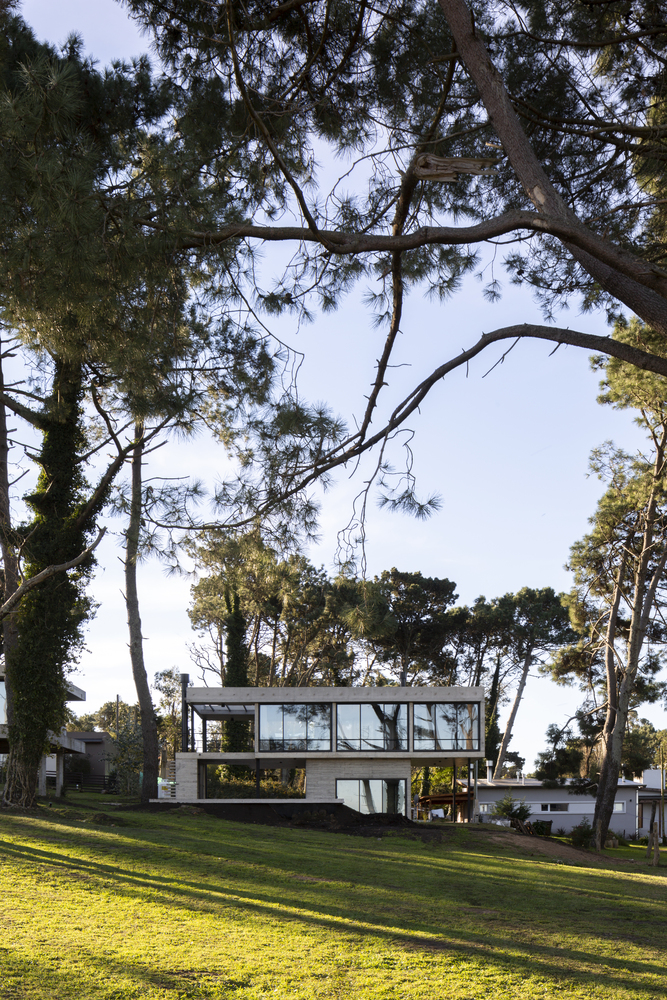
xmin=182 ymin=675 xmax=484 ymax=763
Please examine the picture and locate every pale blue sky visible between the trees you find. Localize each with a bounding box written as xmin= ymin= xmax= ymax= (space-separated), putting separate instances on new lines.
xmin=15 ymin=0 xmax=667 ymax=770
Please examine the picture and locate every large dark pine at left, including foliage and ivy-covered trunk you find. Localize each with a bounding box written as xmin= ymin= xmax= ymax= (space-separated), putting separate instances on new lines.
xmin=0 ymin=11 xmax=284 ymax=804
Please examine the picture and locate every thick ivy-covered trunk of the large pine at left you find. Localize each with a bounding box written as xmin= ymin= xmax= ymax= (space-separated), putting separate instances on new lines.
xmin=4 ymin=359 xmax=94 ymax=807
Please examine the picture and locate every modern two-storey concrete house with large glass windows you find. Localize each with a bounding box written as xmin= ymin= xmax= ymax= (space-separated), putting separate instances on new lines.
xmin=175 ymin=674 xmax=484 ymax=814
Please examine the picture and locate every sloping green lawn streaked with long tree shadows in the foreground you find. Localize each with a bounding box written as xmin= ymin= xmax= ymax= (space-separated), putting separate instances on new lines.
xmin=0 ymin=796 xmax=667 ymax=1000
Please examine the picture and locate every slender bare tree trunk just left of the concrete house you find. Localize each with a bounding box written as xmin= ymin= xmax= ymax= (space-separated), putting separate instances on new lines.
xmin=125 ymin=424 xmax=160 ymax=805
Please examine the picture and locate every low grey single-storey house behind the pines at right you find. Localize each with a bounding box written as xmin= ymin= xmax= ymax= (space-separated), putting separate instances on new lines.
xmin=477 ymin=778 xmax=640 ymax=837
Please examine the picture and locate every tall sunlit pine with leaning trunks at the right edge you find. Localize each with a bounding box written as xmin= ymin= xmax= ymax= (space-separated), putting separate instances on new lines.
xmin=548 ymin=321 xmax=667 ymax=848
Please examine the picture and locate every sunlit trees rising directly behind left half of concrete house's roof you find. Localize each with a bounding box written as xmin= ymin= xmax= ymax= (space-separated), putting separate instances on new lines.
xmin=189 ymin=532 xmax=386 ymax=685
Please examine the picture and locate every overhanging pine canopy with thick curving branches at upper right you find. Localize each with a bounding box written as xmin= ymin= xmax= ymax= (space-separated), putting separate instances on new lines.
xmin=115 ymin=0 xmax=667 ymax=524
